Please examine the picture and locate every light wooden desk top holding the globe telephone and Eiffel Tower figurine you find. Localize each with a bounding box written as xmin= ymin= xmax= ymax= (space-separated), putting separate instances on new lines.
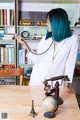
xmin=0 ymin=85 xmax=80 ymax=120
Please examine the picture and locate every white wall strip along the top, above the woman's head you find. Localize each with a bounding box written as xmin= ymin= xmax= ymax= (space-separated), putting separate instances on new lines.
xmin=19 ymin=3 xmax=76 ymax=11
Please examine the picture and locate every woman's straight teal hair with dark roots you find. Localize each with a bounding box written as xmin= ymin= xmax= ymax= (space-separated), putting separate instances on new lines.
xmin=46 ymin=8 xmax=72 ymax=42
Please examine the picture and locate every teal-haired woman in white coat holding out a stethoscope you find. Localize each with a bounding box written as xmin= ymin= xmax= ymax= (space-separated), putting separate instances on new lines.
xmin=16 ymin=8 xmax=78 ymax=91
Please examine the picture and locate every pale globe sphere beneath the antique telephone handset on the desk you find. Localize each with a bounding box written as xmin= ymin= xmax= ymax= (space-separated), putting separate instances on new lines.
xmin=42 ymin=96 xmax=57 ymax=112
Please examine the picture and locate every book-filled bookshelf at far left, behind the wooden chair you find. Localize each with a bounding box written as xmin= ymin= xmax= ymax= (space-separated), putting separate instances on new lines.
xmin=0 ymin=0 xmax=17 ymax=84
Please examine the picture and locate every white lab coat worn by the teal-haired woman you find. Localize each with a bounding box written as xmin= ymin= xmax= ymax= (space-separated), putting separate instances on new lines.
xmin=27 ymin=34 xmax=78 ymax=86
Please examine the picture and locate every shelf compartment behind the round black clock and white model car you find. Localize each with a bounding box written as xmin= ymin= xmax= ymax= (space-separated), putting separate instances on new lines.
xmin=18 ymin=26 xmax=47 ymax=42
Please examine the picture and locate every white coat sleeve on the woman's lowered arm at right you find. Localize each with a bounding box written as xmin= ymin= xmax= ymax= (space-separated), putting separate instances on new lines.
xmin=65 ymin=39 xmax=78 ymax=83
